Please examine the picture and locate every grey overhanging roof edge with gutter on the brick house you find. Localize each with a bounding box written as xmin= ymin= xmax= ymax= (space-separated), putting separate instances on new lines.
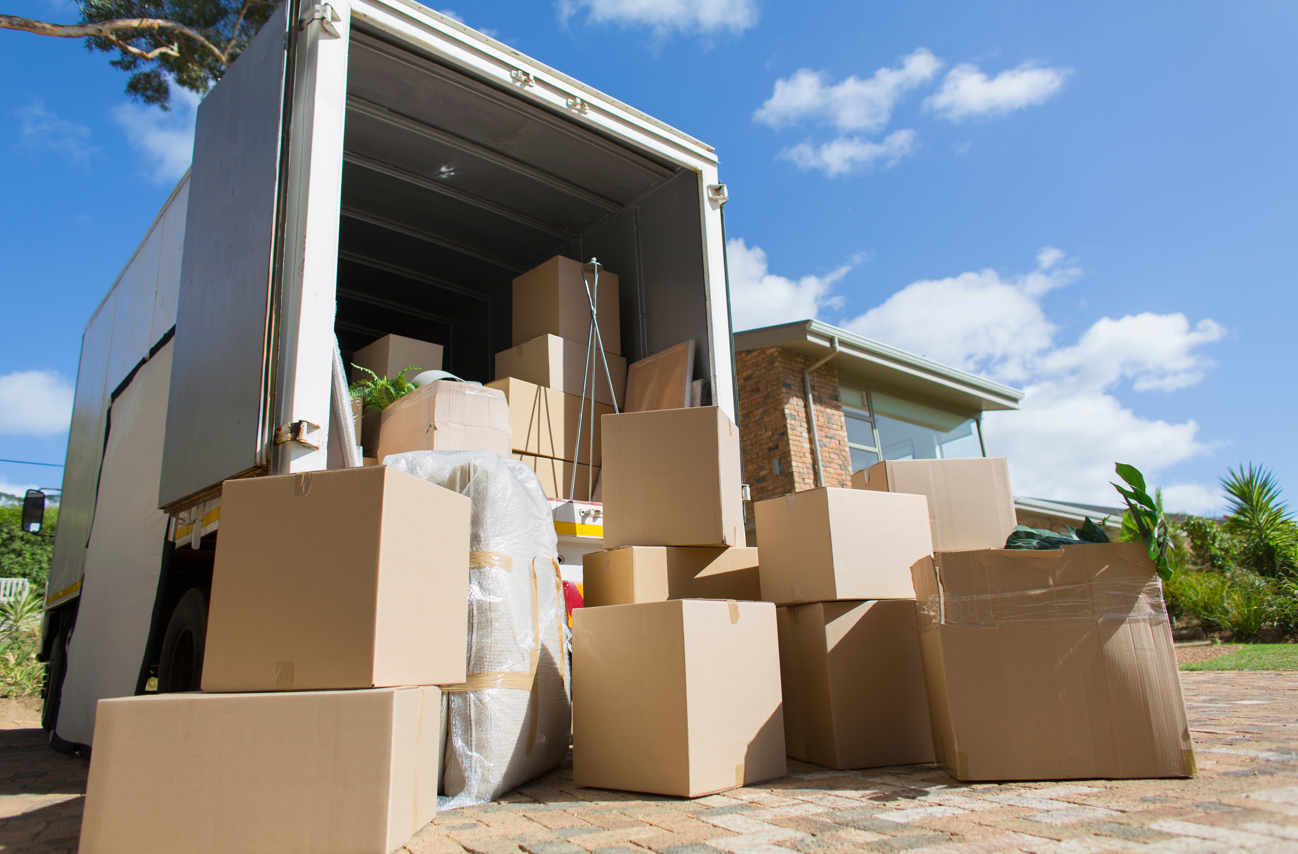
xmin=735 ymin=321 xmax=1023 ymax=413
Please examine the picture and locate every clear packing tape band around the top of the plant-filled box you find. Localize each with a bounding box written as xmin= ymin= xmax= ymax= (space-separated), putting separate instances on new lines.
xmin=919 ymin=576 xmax=1167 ymax=631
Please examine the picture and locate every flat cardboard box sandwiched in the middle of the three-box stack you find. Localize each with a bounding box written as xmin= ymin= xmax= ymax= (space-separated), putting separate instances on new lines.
xmin=582 ymin=545 xmax=762 ymax=607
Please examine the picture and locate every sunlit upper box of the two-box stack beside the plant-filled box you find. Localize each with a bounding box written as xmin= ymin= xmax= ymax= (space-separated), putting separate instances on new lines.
xmin=755 ymin=487 xmax=933 ymax=605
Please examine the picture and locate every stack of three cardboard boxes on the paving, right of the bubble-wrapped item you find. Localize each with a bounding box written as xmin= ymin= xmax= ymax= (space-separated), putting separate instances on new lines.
xmin=572 ymin=406 xmax=785 ymax=797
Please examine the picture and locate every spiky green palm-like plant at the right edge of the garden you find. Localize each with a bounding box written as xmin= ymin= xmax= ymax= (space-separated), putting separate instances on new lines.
xmin=1221 ymin=462 xmax=1298 ymax=578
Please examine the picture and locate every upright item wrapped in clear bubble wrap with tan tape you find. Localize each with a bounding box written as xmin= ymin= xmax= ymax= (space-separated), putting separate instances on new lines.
xmin=384 ymin=450 xmax=572 ymax=810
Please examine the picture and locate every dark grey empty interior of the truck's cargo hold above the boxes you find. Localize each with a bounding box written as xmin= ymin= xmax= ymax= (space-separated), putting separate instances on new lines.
xmin=335 ymin=29 xmax=710 ymax=382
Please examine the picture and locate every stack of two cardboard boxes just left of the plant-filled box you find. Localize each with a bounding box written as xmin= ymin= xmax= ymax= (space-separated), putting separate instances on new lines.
xmin=755 ymin=488 xmax=933 ymax=768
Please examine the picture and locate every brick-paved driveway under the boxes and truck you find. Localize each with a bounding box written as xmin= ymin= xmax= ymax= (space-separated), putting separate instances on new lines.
xmin=0 ymin=672 xmax=1298 ymax=854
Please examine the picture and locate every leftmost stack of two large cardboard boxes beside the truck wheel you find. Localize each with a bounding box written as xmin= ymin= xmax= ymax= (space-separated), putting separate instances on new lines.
xmin=80 ymin=467 xmax=470 ymax=854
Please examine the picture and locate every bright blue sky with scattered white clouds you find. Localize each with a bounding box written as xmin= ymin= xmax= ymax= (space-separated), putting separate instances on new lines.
xmin=0 ymin=0 xmax=1298 ymax=511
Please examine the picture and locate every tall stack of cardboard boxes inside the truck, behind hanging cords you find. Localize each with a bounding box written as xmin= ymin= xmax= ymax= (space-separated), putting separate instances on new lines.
xmin=488 ymin=256 xmax=627 ymax=501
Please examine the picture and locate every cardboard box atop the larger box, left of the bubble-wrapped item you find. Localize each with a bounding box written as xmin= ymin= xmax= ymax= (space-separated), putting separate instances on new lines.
xmin=202 ymin=466 xmax=469 ymax=692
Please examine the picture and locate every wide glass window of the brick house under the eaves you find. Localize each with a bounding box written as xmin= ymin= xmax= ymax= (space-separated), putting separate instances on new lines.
xmin=840 ymin=387 xmax=985 ymax=471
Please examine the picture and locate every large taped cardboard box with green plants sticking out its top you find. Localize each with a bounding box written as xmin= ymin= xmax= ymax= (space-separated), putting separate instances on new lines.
xmin=915 ymin=543 xmax=1194 ymax=780
